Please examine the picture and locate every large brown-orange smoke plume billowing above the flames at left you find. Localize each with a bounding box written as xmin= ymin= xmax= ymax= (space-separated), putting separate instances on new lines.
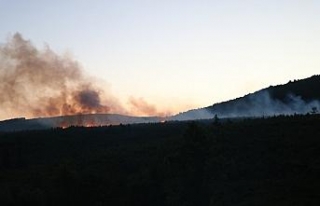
xmin=0 ymin=33 xmax=121 ymax=117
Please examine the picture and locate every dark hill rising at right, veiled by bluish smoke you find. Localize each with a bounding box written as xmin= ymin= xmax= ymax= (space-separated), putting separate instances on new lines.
xmin=171 ymin=75 xmax=320 ymax=120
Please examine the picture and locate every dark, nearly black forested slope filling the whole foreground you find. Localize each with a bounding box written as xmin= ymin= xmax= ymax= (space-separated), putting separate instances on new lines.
xmin=0 ymin=115 xmax=320 ymax=206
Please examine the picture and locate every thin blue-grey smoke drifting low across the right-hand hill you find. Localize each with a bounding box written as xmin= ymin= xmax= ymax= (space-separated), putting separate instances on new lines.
xmin=170 ymin=88 xmax=320 ymax=120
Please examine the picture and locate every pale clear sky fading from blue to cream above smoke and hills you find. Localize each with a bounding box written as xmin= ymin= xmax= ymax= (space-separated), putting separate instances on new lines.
xmin=0 ymin=0 xmax=320 ymax=113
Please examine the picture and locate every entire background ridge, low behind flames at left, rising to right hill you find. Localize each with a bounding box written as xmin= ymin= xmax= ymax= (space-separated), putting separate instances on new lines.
xmin=0 ymin=75 xmax=320 ymax=131
